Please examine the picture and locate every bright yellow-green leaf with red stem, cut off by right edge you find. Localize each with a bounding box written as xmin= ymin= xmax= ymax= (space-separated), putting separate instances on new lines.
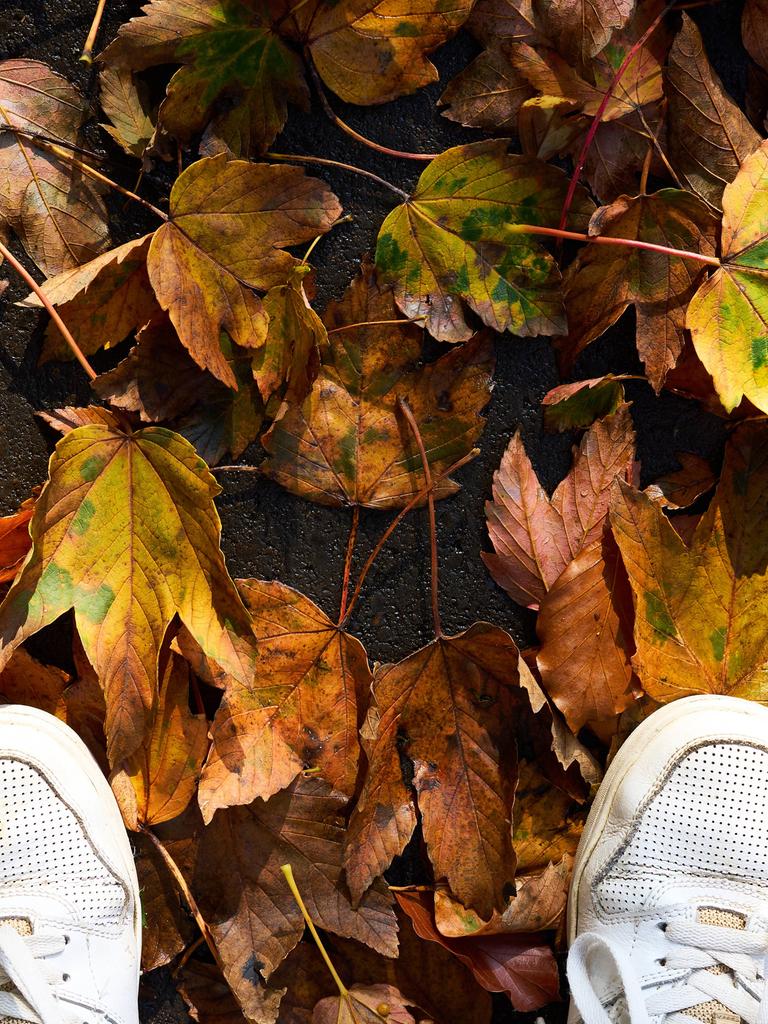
xmin=686 ymin=142 xmax=768 ymax=412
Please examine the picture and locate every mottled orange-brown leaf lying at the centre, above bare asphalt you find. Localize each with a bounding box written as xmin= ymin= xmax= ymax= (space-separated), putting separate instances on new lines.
xmin=263 ymin=267 xmax=494 ymax=508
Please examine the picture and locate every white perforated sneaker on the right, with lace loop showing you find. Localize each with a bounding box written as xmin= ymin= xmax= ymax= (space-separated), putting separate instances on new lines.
xmin=568 ymin=695 xmax=768 ymax=1024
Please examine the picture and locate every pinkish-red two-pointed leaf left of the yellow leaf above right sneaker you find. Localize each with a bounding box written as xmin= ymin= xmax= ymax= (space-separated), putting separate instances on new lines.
xmin=482 ymin=406 xmax=635 ymax=608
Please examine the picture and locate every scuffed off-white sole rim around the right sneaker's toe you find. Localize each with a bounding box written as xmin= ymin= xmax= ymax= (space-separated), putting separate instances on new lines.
xmin=567 ymin=693 xmax=768 ymax=945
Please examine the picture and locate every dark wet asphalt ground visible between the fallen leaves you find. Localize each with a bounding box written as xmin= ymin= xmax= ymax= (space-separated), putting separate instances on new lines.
xmin=0 ymin=0 xmax=746 ymax=1024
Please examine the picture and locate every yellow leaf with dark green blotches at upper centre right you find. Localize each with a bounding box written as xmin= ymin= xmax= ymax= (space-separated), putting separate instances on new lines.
xmin=376 ymin=139 xmax=591 ymax=341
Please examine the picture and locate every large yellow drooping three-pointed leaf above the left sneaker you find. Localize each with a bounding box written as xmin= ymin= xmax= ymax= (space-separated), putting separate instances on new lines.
xmin=0 ymin=411 xmax=254 ymax=764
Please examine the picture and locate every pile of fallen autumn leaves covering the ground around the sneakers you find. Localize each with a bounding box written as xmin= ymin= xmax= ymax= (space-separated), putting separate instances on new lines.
xmin=0 ymin=0 xmax=768 ymax=1024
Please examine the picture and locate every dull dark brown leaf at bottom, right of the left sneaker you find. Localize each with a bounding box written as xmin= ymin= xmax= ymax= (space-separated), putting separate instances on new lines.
xmin=163 ymin=778 xmax=397 ymax=1017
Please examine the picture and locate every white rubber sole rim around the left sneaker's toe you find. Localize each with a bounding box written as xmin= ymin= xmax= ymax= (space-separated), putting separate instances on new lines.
xmin=0 ymin=705 xmax=141 ymax=973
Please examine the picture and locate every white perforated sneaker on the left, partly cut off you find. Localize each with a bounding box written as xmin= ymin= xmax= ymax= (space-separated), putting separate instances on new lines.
xmin=0 ymin=706 xmax=141 ymax=1024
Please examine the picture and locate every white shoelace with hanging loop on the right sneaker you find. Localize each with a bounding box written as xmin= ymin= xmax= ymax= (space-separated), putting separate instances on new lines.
xmin=568 ymin=921 xmax=768 ymax=1024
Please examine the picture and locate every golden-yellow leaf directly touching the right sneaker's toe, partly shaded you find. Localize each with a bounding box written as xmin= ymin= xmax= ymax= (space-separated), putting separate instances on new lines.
xmin=610 ymin=423 xmax=768 ymax=702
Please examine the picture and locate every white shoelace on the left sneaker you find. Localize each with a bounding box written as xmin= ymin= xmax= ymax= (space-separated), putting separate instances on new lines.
xmin=0 ymin=925 xmax=77 ymax=1024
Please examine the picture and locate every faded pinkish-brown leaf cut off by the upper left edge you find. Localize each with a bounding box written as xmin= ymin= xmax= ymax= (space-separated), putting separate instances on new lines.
xmin=0 ymin=59 xmax=110 ymax=276
